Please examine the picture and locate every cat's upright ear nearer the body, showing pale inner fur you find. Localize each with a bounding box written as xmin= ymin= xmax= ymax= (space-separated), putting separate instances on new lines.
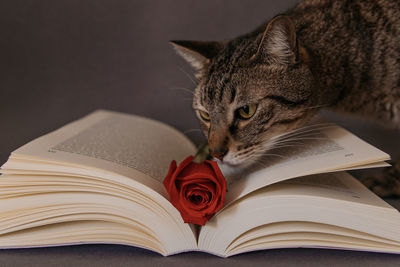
xmin=253 ymin=15 xmax=297 ymax=64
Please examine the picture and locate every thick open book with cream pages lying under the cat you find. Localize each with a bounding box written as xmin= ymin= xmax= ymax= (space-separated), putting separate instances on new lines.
xmin=0 ymin=110 xmax=400 ymax=257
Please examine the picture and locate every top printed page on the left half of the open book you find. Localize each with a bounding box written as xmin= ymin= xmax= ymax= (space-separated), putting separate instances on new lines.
xmin=2 ymin=110 xmax=196 ymax=196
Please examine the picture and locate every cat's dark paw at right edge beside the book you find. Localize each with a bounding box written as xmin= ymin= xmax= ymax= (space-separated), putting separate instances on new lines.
xmin=360 ymin=162 xmax=400 ymax=197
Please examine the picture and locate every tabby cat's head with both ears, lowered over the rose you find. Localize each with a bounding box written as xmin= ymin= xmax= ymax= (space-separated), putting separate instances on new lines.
xmin=171 ymin=16 xmax=316 ymax=166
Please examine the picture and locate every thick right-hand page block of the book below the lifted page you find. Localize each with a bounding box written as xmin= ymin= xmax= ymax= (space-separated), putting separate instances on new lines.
xmin=199 ymin=172 xmax=400 ymax=256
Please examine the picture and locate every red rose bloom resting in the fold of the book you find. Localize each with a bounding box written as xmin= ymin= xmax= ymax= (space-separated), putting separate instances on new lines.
xmin=164 ymin=156 xmax=226 ymax=225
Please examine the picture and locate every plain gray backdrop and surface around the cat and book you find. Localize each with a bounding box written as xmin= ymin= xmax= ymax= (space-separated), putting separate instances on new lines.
xmin=0 ymin=0 xmax=400 ymax=266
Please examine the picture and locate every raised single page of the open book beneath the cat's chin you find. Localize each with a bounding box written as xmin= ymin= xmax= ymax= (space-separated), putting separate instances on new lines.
xmin=221 ymin=122 xmax=390 ymax=204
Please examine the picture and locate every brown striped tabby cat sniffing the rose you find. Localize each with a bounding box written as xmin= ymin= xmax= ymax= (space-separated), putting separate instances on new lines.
xmin=171 ymin=0 xmax=400 ymax=196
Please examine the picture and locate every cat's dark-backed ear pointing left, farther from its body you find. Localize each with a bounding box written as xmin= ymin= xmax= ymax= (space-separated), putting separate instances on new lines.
xmin=170 ymin=41 xmax=224 ymax=70
